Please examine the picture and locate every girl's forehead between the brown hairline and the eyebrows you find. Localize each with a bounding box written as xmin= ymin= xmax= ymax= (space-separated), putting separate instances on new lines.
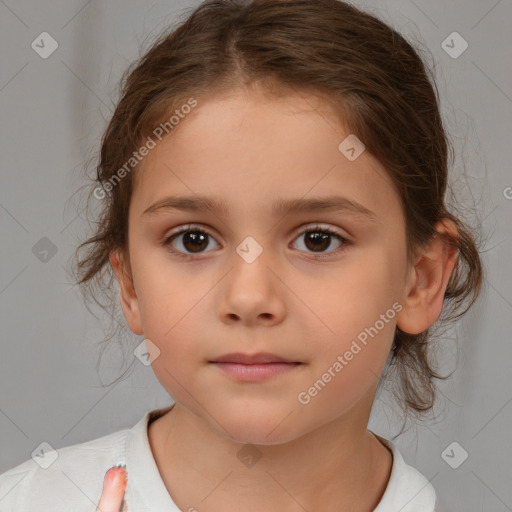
xmin=132 ymin=90 xmax=399 ymax=221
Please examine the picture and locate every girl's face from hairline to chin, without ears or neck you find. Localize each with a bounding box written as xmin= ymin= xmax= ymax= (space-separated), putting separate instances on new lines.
xmin=117 ymin=88 xmax=408 ymax=444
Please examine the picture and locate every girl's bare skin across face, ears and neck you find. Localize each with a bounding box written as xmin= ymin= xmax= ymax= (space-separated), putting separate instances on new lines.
xmin=103 ymin=89 xmax=457 ymax=512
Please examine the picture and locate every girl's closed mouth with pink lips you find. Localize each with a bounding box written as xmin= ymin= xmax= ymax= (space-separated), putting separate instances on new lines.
xmin=208 ymin=353 xmax=303 ymax=382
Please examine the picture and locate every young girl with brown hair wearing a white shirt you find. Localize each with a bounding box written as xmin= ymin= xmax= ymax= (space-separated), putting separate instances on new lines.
xmin=0 ymin=0 xmax=482 ymax=512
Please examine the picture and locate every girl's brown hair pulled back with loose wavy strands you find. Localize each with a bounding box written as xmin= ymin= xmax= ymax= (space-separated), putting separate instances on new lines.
xmin=72 ymin=0 xmax=483 ymax=424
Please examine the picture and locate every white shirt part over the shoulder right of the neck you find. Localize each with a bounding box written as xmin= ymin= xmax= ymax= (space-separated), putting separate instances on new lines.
xmin=374 ymin=436 xmax=436 ymax=512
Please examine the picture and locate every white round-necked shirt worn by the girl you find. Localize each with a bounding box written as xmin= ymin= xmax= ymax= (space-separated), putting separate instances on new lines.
xmin=0 ymin=405 xmax=436 ymax=512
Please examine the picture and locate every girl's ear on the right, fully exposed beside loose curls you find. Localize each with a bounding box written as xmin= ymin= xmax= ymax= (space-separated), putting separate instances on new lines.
xmin=397 ymin=219 xmax=459 ymax=334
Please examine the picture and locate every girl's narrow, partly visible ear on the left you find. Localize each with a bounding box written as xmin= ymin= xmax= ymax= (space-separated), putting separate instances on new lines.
xmin=109 ymin=249 xmax=143 ymax=335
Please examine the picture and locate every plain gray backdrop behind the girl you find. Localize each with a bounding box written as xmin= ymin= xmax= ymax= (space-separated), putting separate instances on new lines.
xmin=0 ymin=0 xmax=512 ymax=512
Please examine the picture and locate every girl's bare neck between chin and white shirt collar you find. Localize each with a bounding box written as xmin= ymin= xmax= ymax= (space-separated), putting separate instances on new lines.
xmin=148 ymin=403 xmax=392 ymax=512
